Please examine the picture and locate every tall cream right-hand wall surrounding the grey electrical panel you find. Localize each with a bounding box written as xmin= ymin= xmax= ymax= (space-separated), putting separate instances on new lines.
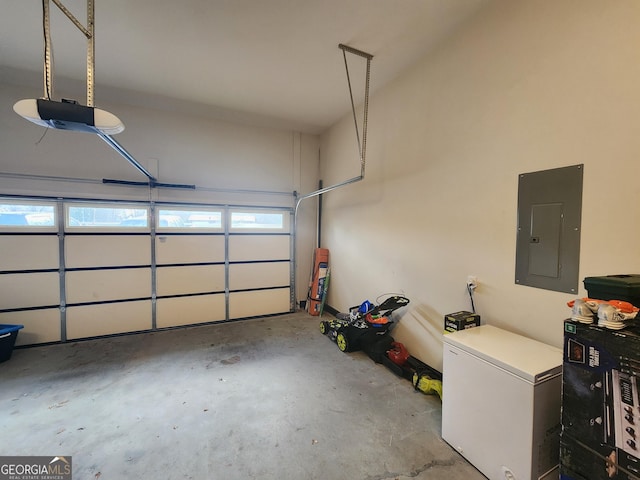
xmin=321 ymin=0 xmax=640 ymax=368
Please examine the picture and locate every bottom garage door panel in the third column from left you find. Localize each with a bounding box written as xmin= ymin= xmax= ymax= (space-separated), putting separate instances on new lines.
xmin=156 ymin=294 xmax=225 ymax=328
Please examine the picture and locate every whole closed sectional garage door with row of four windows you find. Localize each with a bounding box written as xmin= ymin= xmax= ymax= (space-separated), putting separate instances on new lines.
xmin=0 ymin=198 xmax=293 ymax=345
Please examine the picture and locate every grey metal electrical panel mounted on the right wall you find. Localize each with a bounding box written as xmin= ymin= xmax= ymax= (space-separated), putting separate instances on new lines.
xmin=516 ymin=165 xmax=584 ymax=293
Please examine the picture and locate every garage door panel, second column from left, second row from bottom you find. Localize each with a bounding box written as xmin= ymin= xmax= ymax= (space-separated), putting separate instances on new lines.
xmin=66 ymin=268 xmax=151 ymax=303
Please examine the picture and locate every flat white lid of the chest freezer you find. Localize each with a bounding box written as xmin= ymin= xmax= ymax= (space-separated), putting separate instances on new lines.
xmin=444 ymin=325 xmax=562 ymax=383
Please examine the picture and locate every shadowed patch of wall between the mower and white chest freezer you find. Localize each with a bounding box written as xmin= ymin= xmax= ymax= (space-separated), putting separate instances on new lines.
xmin=392 ymin=304 xmax=444 ymax=372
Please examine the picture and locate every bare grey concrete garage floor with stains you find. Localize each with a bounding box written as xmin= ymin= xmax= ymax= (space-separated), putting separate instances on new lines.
xmin=0 ymin=313 xmax=485 ymax=480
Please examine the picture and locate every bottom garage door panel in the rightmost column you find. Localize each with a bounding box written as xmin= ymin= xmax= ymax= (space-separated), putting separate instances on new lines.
xmin=229 ymin=288 xmax=291 ymax=318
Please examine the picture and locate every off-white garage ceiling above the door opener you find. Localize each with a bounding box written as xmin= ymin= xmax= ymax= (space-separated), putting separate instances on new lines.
xmin=0 ymin=0 xmax=491 ymax=133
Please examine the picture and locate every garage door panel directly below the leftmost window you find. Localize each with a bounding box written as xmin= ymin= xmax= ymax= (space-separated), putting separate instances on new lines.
xmin=0 ymin=235 xmax=60 ymax=271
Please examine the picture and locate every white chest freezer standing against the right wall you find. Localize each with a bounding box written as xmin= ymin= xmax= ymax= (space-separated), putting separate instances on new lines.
xmin=442 ymin=325 xmax=562 ymax=480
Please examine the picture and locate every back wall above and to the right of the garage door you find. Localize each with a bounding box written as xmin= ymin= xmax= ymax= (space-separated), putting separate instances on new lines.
xmin=0 ymin=77 xmax=319 ymax=304
